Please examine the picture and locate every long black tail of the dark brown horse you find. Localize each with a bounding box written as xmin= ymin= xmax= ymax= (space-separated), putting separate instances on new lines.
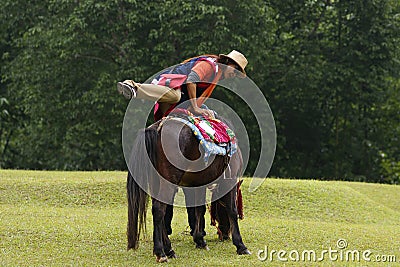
xmin=126 ymin=128 xmax=157 ymax=250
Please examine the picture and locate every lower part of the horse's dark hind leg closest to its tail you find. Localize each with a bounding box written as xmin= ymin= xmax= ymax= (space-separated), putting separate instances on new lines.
xmin=151 ymin=198 xmax=171 ymax=262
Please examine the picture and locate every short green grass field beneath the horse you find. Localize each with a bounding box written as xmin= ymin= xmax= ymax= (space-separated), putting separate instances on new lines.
xmin=0 ymin=170 xmax=400 ymax=266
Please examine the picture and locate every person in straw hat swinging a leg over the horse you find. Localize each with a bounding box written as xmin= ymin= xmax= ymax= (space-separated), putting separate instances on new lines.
xmin=117 ymin=50 xmax=248 ymax=117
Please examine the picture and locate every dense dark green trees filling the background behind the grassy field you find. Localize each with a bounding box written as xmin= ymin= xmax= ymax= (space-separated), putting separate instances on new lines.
xmin=0 ymin=0 xmax=400 ymax=182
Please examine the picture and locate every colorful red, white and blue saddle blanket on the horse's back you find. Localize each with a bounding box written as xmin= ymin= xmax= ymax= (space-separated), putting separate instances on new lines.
xmin=168 ymin=109 xmax=237 ymax=163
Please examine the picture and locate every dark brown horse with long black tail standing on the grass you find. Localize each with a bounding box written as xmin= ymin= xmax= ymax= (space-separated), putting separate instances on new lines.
xmin=127 ymin=115 xmax=250 ymax=262
